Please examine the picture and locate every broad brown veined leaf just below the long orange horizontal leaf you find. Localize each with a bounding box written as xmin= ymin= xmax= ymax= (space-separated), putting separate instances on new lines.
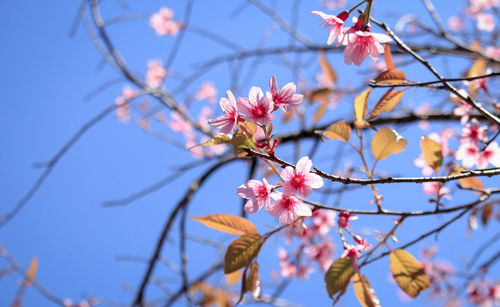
xmin=224 ymin=233 xmax=262 ymax=274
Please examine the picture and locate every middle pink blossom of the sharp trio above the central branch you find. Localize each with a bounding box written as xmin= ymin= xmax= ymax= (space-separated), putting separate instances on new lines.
xmin=238 ymin=86 xmax=275 ymax=125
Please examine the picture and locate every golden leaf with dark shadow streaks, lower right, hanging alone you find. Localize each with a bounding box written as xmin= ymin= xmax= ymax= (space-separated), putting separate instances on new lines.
xmin=389 ymin=249 xmax=429 ymax=298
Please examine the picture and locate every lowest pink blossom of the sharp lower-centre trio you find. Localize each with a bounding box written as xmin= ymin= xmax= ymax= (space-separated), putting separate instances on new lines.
xmin=268 ymin=192 xmax=312 ymax=224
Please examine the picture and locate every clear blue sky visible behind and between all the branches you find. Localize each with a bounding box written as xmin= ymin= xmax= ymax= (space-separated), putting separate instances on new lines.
xmin=0 ymin=0 xmax=499 ymax=306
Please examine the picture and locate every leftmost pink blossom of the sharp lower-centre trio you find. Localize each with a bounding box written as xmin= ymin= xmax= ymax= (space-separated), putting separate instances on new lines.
xmin=237 ymin=178 xmax=273 ymax=213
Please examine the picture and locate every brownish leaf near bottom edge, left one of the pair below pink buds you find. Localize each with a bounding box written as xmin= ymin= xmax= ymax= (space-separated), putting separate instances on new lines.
xmin=325 ymin=258 xmax=354 ymax=297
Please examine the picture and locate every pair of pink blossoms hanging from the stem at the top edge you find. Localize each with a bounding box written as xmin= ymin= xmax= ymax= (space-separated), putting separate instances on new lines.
xmin=312 ymin=1 xmax=392 ymax=66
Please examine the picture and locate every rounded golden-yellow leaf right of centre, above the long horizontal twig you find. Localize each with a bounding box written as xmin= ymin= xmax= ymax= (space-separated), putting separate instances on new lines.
xmin=372 ymin=127 xmax=408 ymax=160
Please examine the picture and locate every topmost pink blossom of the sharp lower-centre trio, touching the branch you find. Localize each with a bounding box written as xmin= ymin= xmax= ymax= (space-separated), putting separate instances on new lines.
xmin=281 ymin=156 xmax=323 ymax=197
